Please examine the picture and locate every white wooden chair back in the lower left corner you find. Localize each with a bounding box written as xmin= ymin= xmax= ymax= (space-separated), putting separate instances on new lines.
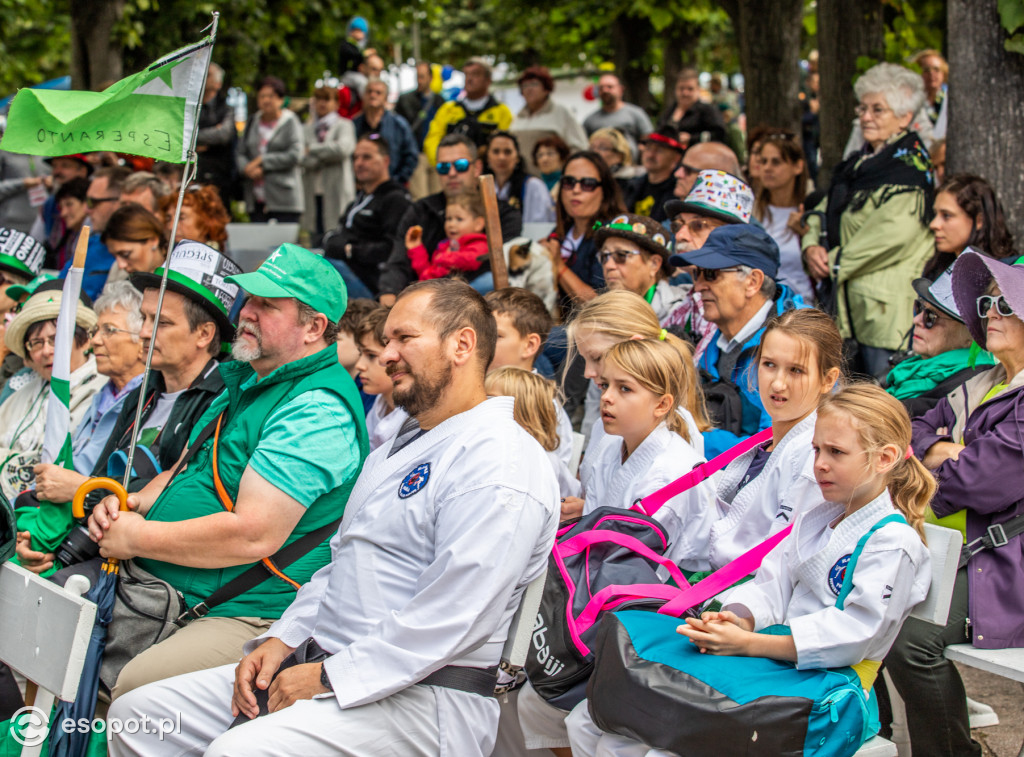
xmin=0 ymin=562 xmax=96 ymax=757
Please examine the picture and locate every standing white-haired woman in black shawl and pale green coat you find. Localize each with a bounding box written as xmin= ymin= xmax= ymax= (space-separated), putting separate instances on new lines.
xmin=802 ymin=64 xmax=934 ymax=377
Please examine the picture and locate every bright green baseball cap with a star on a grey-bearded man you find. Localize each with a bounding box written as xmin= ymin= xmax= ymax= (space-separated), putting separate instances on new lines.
xmin=227 ymin=244 xmax=348 ymax=324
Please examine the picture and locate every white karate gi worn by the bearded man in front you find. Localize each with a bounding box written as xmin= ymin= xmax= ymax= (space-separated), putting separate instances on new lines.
xmin=111 ymin=397 xmax=558 ymax=757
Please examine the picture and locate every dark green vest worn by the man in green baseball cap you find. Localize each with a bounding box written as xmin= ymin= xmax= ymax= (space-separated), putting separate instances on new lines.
xmin=137 ymin=344 xmax=369 ymax=618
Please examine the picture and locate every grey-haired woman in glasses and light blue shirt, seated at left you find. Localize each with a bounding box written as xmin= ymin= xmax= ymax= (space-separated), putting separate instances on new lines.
xmin=35 ymin=282 xmax=145 ymax=502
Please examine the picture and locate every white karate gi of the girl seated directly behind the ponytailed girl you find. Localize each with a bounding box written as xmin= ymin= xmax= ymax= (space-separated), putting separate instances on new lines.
xmin=710 ymin=413 xmax=821 ymax=570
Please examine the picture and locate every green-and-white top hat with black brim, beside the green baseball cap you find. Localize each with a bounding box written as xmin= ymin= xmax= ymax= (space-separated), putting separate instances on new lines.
xmin=130 ymin=240 xmax=242 ymax=341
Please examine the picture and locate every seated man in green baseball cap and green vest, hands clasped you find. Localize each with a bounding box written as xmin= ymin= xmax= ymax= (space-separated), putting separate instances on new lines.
xmin=89 ymin=245 xmax=368 ymax=699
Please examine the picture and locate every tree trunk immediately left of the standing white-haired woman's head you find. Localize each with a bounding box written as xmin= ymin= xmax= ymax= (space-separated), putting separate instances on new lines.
xmin=818 ymin=0 xmax=886 ymax=186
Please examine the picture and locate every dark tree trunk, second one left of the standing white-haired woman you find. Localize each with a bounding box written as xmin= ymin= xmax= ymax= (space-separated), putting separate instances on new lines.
xmin=721 ymin=0 xmax=804 ymax=133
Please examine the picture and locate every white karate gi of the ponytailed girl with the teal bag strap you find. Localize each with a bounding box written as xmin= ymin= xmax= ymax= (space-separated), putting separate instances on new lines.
xmin=565 ymin=492 xmax=932 ymax=757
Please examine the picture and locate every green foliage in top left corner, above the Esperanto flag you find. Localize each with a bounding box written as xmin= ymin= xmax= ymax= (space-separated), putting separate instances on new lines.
xmin=0 ymin=0 xmax=71 ymax=96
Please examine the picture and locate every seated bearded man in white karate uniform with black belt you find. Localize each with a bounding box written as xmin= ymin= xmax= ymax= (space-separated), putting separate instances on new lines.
xmin=110 ymin=280 xmax=558 ymax=757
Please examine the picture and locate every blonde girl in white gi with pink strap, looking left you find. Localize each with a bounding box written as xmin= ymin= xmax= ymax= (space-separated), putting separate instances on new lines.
xmin=582 ymin=339 xmax=718 ymax=573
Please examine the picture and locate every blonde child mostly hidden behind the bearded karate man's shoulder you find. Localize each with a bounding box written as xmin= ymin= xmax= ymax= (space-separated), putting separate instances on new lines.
xmin=483 ymin=366 xmax=580 ymax=497
